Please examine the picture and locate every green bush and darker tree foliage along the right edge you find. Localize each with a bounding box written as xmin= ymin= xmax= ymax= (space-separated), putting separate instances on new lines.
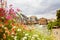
xmin=47 ymin=10 xmax=60 ymax=30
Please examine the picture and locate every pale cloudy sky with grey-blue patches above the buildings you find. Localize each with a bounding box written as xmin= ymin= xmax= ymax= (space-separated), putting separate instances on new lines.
xmin=7 ymin=0 xmax=60 ymax=18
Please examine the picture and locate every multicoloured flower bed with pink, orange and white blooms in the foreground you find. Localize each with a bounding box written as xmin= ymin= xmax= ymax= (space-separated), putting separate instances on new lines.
xmin=0 ymin=8 xmax=53 ymax=40
